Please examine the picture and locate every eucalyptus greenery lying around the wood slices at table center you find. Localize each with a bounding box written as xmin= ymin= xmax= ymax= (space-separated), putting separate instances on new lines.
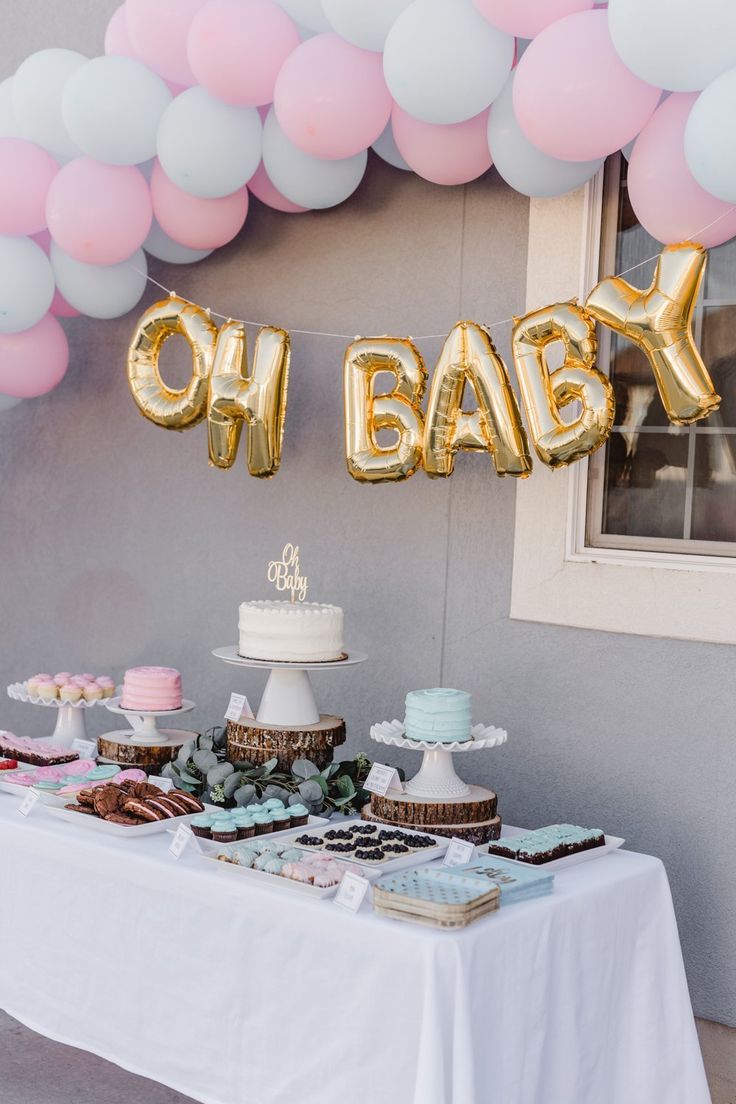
xmin=161 ymin=728 xmax=371 ymax=817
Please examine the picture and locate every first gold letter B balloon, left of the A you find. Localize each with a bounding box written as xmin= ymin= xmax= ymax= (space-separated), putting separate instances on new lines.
xmin=344 ymin=338 xmax=427 ymax=482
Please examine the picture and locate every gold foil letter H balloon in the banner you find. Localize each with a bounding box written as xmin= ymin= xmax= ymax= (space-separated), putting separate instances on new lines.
xmin=207 ymin=322 xmax=291 ymax=478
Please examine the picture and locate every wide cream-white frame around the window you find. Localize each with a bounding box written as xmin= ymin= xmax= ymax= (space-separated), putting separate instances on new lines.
xmin=510 ymin=170 xmax=736 ymax=644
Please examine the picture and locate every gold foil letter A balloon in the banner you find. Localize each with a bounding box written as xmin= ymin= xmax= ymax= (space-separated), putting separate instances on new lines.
xmin=424 ymin=322 xmax=532 ymax=478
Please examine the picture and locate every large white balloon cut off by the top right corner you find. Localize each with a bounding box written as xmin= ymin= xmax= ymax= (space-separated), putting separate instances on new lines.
xmin=608 ymin=0 xmax=736 ymax=92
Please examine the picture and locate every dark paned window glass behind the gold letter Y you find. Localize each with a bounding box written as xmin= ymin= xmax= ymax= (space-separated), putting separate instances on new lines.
xmin=585 ymin=158 xmax=736 ymax=556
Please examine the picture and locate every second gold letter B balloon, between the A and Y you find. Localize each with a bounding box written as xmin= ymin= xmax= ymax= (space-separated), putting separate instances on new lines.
xmin=513 ymin=302 xmax=616 ymax=468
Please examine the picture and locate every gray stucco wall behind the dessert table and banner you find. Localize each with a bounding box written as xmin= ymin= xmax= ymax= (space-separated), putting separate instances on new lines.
xmin=5 ymin=0 xmax=736 ymax=1023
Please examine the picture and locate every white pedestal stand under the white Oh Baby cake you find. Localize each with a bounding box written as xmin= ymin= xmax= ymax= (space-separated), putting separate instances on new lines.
xmin=212 ymin=645 xmax=367 ymax=728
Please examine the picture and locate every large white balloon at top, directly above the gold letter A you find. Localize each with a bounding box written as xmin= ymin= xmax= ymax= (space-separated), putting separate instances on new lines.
xmin=383 ymin=0 xmax=514 ymax=123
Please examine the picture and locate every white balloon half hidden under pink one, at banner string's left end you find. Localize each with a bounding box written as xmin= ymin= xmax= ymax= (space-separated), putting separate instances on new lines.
xmin=51 ymin=242 xmax=148 ymax=318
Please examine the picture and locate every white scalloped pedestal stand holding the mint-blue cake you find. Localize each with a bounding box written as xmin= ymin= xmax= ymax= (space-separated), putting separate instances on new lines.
xmin=371 ymin=721 xmax=509 ymax=802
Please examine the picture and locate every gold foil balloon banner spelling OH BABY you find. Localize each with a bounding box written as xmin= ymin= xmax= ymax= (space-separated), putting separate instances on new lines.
xmin=128 ymin=243 xmax=721 ymax=482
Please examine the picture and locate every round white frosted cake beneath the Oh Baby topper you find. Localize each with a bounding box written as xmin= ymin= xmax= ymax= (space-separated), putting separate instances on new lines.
xmin=237 ymin=602 xmax=344 ymax=664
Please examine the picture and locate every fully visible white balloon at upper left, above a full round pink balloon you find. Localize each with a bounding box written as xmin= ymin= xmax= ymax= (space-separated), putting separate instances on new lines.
xmin=62 ymin=56 xmax=172 ymax=164
